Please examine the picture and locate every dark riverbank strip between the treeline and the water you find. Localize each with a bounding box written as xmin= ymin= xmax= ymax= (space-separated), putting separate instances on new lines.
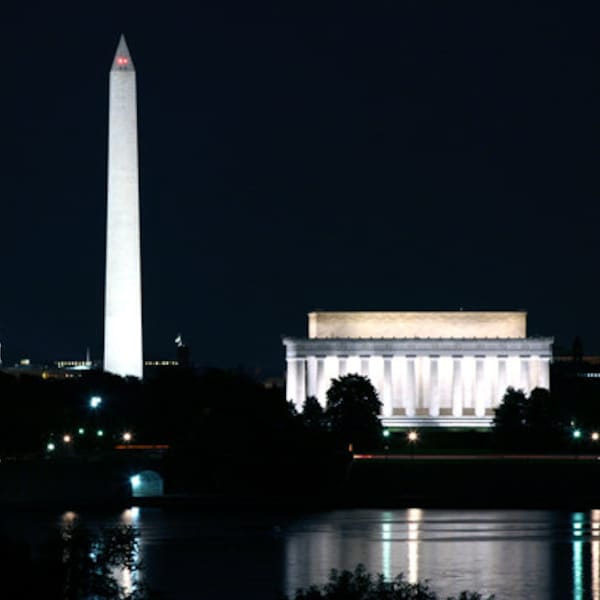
xmin=0 ymin=454 xmax=600 ymax=511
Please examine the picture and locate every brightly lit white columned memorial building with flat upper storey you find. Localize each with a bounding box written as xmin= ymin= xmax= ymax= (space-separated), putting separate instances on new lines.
xmin=283 ymin=311 xmax=553 ymax=427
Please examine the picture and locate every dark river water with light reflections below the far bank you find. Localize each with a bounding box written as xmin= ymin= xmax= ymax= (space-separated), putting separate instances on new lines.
xmin=0 ymin=507 xmax=600 ymax=600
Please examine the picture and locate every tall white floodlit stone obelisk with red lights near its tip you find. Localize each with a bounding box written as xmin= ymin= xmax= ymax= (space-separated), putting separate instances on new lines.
xmin=104 ymin=36 xmax=144 ymax=377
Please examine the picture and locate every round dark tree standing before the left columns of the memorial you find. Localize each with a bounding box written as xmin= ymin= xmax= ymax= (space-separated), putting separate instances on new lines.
xmin=325 ymin=374 xmax=381 ymax=447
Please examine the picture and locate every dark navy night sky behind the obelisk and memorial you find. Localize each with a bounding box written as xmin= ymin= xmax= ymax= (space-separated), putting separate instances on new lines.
xmin=0 ymin=0 xmax=600 ymax=373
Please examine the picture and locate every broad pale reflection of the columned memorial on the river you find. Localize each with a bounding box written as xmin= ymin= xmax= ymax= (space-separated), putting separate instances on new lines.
xmin=284 ymin=508 xmax=556 ymax=600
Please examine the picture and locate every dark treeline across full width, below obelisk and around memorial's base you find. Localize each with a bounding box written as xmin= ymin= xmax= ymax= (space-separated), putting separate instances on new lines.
xmin=0 ymin=368 xmax=600 ymax=462
